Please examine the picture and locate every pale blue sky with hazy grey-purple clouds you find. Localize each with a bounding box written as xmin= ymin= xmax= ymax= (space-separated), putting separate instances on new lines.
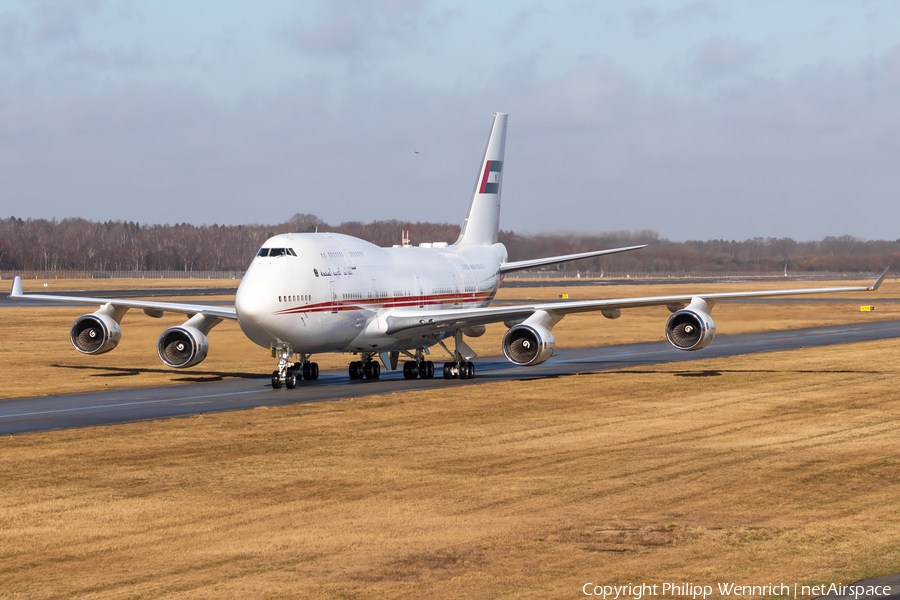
xmin=0 ymin=0 xmax=900 ymax=241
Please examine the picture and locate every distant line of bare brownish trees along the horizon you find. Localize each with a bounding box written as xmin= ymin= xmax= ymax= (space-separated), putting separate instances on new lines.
xmin=0 ymin=213 xmax=900 ymax=274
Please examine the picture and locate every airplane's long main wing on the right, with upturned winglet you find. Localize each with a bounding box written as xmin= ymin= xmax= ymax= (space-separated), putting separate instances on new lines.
xmin=386 ymin=267 xmax=890 ymax=336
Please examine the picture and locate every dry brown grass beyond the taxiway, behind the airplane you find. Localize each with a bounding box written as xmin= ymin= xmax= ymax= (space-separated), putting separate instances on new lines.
xmin=0 ymin=279 xmax=900 ymax=400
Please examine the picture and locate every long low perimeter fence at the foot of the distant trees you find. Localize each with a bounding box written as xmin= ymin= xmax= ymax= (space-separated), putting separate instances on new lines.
xmin=0 ymin=271 xmax=884 ymax=280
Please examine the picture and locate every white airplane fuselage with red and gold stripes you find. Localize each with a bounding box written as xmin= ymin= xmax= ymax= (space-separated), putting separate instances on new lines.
xmin=235 ymin=233 xmax=507 ymax=354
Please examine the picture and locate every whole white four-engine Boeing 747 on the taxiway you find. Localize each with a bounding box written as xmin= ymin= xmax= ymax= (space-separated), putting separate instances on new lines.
xmin=10 ymin=113 xmax=888 ymax=389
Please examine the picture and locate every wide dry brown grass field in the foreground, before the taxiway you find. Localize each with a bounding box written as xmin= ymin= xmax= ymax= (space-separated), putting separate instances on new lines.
xmin=0 ymin=340 xmax=900 ymax=598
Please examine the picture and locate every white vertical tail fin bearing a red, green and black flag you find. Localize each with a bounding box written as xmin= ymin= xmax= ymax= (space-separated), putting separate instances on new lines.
xmin=456 ymin=113 xmax=509 ymax=246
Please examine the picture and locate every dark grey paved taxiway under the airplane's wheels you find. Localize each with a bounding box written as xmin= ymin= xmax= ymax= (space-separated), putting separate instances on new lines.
xmin=0 ymin=321 xmax=900 ymax=435
